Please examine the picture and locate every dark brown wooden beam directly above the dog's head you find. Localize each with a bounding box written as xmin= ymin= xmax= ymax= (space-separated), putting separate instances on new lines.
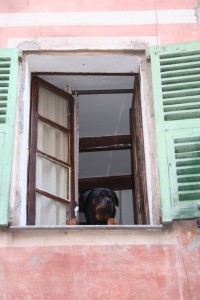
xmin=79 ymin=175 xmax=133 ymax=192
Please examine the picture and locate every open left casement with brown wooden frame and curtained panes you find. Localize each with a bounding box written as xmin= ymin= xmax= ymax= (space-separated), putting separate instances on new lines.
xmin=27 ymin=76 xmax=74 ymax=225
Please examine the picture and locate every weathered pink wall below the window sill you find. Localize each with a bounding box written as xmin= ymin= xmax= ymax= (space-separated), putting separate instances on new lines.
xmin=0 ymin=221 xmax=200 ymax=300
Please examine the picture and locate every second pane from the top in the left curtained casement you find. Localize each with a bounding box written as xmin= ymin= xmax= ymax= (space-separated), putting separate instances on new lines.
xmin=37 ymin=121 xmax=69 ymax=162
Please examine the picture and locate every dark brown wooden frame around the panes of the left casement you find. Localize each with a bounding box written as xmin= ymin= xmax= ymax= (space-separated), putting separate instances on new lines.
xmin=27 ymin=76 xmax=75 ymax=225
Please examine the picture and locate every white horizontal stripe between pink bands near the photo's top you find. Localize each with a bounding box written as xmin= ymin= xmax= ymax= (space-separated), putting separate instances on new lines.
xmin=0 ymin=9 xmax=196 ymax=27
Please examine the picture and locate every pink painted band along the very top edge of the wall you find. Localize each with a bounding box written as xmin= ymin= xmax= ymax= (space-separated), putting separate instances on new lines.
xmin=0 ymin=0 xmax=197 ymax=13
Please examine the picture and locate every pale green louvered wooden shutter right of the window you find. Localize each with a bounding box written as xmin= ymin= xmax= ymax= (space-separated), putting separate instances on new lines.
xmin=151 ymin=41 xmax=200 ymax=222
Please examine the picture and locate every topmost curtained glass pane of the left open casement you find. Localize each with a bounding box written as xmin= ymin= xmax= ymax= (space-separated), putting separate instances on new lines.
xmin=38 ymin=87 xmax=69 ymax=128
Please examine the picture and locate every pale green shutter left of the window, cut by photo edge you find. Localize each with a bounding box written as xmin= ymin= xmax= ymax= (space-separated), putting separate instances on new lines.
xmin=0 ymin=49 xmax=18 ymax=225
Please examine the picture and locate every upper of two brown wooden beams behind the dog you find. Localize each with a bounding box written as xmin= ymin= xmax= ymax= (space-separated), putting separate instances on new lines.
xmin=79 ymin=135 xmax=131 ymax=152
